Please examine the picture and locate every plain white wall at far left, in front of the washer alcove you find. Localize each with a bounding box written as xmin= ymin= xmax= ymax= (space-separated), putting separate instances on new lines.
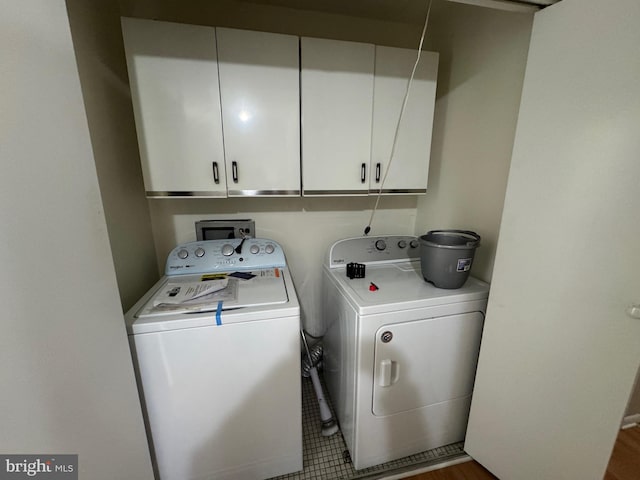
xmin=0 ymin=0 xmax=153 ymax=480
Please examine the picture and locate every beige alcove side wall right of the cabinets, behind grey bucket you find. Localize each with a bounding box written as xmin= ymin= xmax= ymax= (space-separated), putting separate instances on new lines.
xmin=415 ymin=2 xmax=533 ymax=281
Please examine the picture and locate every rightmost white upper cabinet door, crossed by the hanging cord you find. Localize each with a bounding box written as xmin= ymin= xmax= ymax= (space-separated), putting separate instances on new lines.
xmin=370 ymin=46 xmax=438 ymax=194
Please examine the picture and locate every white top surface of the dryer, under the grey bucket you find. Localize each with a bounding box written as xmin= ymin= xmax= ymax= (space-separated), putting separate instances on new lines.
xmin=325 ymin=261 xmax=489 ymax=315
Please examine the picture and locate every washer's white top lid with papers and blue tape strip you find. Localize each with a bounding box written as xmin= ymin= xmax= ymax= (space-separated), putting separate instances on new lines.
xmin=125 ymin=268 xmax=299 ymax=334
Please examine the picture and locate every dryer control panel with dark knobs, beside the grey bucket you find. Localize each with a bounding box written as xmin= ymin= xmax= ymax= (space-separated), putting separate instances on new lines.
xmin=327 ymin=235 xmax=420 ymax=268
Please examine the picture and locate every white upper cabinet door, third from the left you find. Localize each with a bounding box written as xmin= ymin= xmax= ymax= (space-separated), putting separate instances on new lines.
xmin=300 ymin=38 xmax=375 ymax=196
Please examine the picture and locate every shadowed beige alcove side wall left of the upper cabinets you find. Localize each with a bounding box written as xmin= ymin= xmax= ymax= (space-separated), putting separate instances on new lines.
xmin=67 ymin=0 xmax=158 ymax=310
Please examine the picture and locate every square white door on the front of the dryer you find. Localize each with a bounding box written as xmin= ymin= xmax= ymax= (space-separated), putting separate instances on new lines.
xmin=373 ymin=312 xmax=484 ymax=416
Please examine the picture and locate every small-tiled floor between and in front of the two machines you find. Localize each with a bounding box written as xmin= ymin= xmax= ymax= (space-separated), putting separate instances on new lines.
xmin=273 ymin=378 xmax=464 ymax=480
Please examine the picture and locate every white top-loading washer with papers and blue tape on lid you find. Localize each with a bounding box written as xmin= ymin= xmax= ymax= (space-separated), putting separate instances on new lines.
xmin=126 ymin=238 xmax=302 ymax=480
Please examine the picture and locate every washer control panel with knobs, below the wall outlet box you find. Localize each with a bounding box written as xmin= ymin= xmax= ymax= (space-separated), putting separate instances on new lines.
xmin=165 ymin=238 xmax=286 ymax=275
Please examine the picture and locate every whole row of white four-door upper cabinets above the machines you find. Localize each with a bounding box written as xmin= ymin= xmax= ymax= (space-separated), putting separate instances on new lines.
xmin=122 ymin=18 xmax=438 ymax=197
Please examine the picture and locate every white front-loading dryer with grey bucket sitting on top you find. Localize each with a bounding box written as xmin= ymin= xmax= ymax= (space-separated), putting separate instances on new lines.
xmin=323 ymin=235 xmax=489 ymax=469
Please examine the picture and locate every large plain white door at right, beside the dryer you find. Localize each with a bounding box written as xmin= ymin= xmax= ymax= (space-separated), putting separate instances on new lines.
xmin=465 ymin=0 xmax=640 ymax=480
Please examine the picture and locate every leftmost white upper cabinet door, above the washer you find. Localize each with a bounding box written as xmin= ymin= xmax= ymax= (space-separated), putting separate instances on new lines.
xmin=122 ymin=18 xmax=227 ymax=197
